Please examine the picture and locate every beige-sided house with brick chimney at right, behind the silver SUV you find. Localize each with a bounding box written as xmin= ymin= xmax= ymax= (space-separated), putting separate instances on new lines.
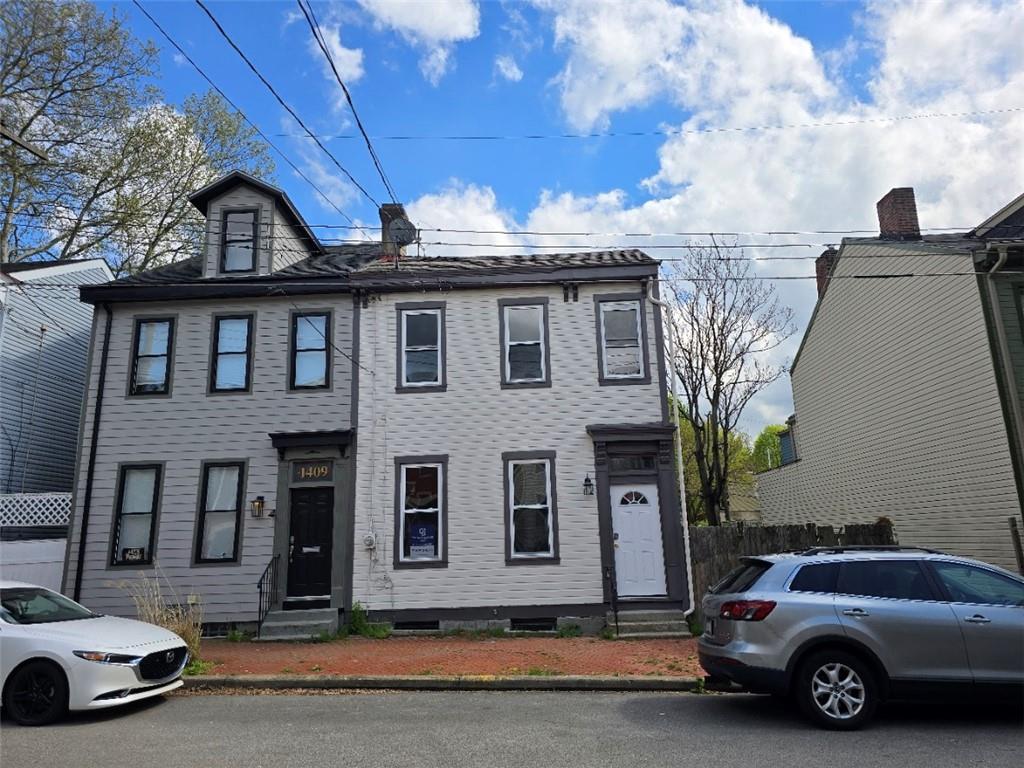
xmin=758 ymin=188 xmax=1024 ymax=570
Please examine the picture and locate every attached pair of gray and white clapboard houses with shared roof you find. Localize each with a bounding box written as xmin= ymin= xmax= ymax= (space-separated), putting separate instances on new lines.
xmin=65 ymin=172 xmax=687 ymax=635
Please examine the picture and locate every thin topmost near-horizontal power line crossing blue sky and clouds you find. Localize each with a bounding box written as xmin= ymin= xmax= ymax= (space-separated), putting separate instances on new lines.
xmin=278 ymin=106 xmax=1024 ymax=141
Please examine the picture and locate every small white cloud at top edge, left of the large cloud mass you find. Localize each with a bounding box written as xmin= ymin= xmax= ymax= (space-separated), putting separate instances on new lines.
xmin=358 ymin=0 xmax=480 ymax=85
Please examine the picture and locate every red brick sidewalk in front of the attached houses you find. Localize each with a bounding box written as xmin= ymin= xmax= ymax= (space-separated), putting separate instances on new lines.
xmin=196 ymin=637 xmax=703 ymax=677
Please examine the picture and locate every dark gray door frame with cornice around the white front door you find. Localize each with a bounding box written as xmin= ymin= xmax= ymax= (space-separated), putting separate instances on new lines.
xmin=587 ymin=424 xmax=689 ymax=608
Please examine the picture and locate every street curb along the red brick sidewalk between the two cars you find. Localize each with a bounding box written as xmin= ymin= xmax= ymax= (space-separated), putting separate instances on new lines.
xmin=184 ymin=675 xmax=699 ymax=692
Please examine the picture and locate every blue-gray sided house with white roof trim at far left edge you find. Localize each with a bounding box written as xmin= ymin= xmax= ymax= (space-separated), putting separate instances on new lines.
xmin=0 ymin=259 xmax=114 ymax=494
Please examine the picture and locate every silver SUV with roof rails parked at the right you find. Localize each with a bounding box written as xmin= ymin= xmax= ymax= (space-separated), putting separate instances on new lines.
xmin=698 ymin=547 xmax=1024 ymax=729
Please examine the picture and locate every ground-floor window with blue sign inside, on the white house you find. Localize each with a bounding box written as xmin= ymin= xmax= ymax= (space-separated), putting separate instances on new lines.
xmin=395 ymin=456 xmax=447 ymax=567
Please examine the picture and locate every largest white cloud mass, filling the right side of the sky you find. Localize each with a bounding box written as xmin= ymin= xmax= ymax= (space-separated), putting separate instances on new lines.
xmin=411 ymin=0 xmax=1024 ymax=432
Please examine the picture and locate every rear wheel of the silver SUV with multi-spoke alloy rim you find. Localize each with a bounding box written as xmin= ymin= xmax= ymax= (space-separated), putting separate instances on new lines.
xmin=797 ymin=650 xmax=879 ymax=730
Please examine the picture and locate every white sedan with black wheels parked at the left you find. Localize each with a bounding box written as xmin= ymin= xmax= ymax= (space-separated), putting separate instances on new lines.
xmin=0 ymin=581 xmax=188 ymax=725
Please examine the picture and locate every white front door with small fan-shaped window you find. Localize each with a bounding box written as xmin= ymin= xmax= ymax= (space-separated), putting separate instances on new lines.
xmin=610 ymin=484 xmax=666 ymax=597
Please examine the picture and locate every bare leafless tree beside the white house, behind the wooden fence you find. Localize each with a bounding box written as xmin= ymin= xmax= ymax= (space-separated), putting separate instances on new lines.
xmin=667 ymin=247 xmax=796 ymax=525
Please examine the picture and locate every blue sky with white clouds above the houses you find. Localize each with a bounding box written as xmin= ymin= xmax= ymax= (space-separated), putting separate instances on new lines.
xmin=105 ymin=0 xmax=1024 ymax=432
